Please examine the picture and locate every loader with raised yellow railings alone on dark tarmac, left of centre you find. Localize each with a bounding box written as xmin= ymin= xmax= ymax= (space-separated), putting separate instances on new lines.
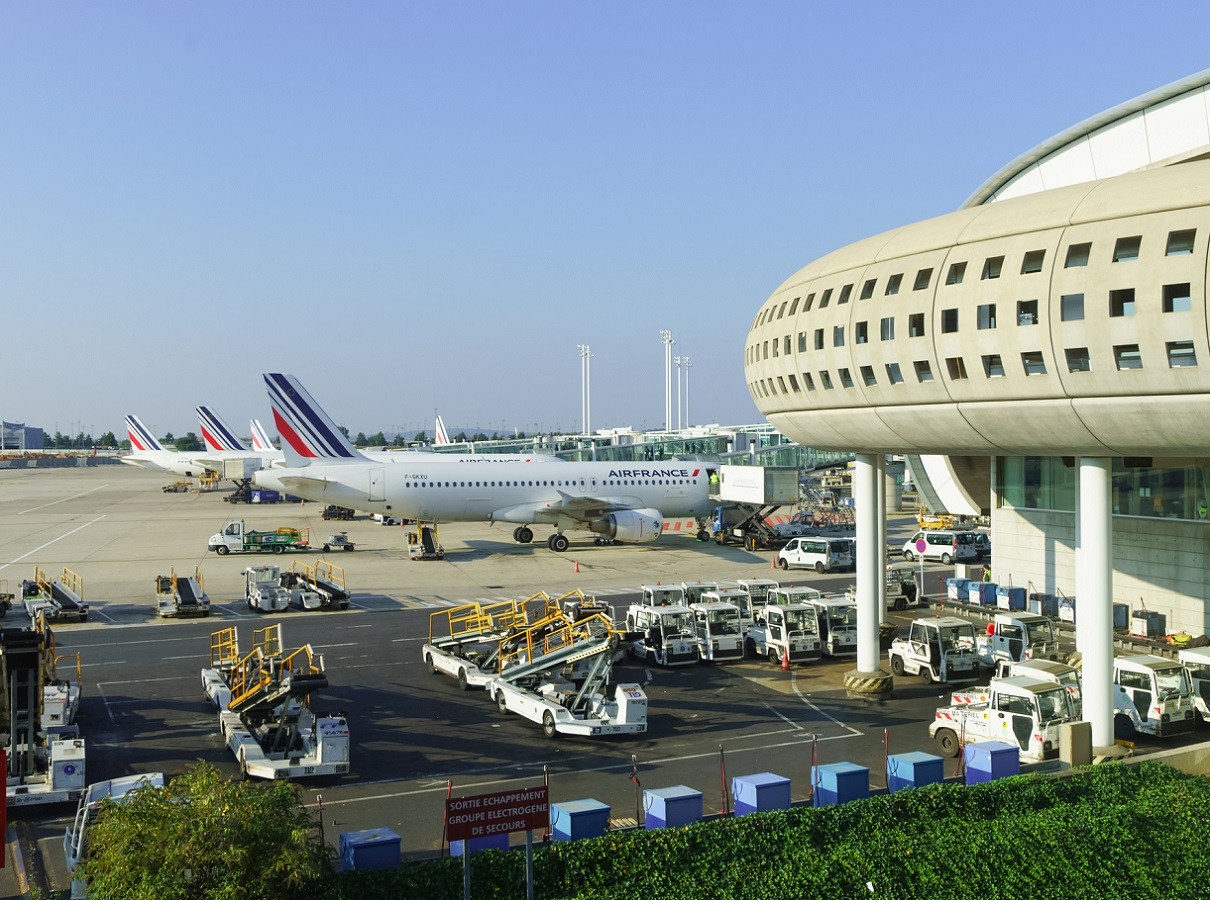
xmin=202 ymin=625 xmax=350 ymax=780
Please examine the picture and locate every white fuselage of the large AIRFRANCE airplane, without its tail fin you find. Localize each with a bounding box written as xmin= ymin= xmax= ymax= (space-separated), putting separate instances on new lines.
xmin=254 ymin=461 xmax=714 ymax=525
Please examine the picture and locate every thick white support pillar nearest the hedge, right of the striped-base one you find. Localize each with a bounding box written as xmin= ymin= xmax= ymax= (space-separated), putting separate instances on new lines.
xmin=1076 ymin=457 xmax=1113 ymax=755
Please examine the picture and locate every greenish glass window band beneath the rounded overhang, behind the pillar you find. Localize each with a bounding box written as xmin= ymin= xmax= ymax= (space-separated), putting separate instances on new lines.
xmin=996 ymin=456 xmax=1210 ymax=521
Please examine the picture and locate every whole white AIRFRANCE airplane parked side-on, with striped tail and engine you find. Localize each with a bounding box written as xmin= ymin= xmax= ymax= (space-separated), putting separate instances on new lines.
xmin=253 ymin=374 xmax=714 ymax=553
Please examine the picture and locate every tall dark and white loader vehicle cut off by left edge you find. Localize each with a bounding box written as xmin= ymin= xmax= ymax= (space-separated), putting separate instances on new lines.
xmin=0 ymin=619 xmax=86 ymax=807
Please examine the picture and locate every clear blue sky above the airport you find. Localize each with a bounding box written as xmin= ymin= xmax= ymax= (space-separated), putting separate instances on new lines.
xmin=0 ymin=0 xmax=1210 ymax=438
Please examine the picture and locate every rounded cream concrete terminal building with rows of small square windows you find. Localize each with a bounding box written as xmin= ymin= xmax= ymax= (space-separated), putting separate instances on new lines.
xmin=744 ymin=70 xmax=1210 ymax=743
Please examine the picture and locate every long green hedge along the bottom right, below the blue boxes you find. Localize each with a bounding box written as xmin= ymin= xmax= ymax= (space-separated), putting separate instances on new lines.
xmin=333 ymin=762 xmax=1210 ymax=900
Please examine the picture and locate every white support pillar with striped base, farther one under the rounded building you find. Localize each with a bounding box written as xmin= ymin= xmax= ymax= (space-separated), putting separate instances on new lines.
xmin=845 ymin=454 xmax=892 ymax=700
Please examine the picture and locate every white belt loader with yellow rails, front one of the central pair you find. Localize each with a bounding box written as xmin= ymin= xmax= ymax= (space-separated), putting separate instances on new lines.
xmin=485 ymin=610 xmax=648 ymax=738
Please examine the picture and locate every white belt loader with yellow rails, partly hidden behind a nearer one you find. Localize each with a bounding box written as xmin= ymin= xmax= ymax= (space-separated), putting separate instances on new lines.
xmin=421 ymin=594 xmax=552 ymax=691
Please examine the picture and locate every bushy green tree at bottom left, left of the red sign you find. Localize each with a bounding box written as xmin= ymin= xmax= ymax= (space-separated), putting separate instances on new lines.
xmin=79 ymin=762 xmax=333 ymax=900
